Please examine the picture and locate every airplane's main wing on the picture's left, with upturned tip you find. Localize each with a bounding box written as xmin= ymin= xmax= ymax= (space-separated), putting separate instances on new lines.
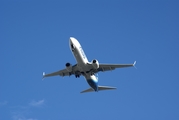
xmin=43 ymin=65 xmax=78 ymax=78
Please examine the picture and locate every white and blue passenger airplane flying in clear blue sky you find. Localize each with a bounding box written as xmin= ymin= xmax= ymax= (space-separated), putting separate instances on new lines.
xmin=43 ymin=37 xmax=136 ymax=93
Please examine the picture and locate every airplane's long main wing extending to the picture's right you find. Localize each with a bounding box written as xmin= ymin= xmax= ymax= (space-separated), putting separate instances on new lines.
xmin=91 ymin=61 xmax=136 ymax=73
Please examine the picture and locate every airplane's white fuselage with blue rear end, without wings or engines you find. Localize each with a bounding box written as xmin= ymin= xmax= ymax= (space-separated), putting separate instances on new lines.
xmin=69 ymin=37 xmax=98 ymax=91
